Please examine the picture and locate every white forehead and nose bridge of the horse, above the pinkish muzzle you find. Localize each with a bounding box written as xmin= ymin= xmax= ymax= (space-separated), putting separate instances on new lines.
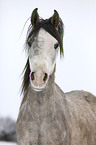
xmin=29 ymin=28 xmax=58 ymax=75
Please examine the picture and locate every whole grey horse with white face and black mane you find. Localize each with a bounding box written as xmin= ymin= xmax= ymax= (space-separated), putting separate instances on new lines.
xmin=16 ymin=8 xmax=96 ymax=145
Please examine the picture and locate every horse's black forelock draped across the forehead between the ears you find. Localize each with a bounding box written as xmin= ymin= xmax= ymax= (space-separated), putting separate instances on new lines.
xmin=26 ymin=18 xmax=64 ymax=56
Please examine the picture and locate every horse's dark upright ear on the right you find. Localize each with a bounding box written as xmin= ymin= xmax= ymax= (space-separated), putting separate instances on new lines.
xmin=51 ymin=10 xmax=59 ymax=30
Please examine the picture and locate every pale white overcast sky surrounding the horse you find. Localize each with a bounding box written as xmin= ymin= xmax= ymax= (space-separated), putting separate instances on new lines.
xmin=0 ymin=0 xmax=96 ymax=120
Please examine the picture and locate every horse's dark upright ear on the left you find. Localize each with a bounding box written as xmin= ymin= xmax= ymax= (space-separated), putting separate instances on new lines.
xmin=31 ymin=8 xmax=39 ymax=27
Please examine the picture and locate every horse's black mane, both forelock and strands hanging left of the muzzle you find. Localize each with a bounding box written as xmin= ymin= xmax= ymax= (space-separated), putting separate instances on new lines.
xmin=21 ymin=13 xmax=64 ymax=95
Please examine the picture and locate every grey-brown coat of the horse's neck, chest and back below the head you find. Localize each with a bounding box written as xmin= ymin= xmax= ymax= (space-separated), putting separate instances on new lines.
xmin=17 ymin=73 xmax=96 ymax=145
